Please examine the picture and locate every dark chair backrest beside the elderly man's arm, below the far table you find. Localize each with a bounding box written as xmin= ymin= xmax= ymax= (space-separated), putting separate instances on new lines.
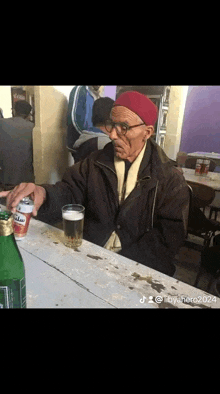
xmin=187 ymin=181 xmax=215 ymax=208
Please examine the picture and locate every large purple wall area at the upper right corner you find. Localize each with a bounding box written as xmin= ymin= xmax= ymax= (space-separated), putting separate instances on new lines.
xmin=180 ymin=86 xmax=220 ymax=153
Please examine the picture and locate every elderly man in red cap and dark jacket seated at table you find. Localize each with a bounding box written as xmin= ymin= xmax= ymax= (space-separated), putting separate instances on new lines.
xmin=0 ymin=92 xmax=189 ymax=276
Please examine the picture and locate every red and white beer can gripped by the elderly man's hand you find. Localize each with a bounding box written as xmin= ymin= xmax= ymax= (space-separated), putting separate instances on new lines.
xmin=13 ymin=197 xmax=34 ymax=241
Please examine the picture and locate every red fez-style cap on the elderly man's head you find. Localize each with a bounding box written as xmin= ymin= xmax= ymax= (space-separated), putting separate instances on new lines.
xmin=113 ymin=92 xmax=158 ymax=126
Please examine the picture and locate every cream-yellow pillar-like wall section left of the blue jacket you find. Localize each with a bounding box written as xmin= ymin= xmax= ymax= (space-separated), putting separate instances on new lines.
xmin=33 ymin=85 xmax=69 ymax=184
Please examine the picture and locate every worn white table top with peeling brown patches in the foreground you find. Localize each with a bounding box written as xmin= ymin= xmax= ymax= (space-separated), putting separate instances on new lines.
xmin=0 ymin=209 xmax=212 ymax=309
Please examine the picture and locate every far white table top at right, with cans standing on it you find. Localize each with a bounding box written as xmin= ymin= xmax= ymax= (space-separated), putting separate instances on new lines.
xmin=183 ymin=168 xmax=220 ymax=191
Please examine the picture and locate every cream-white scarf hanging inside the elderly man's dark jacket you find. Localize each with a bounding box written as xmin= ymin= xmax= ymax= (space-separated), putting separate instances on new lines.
xmin=104 ymin=143 xmax=147 ymax=253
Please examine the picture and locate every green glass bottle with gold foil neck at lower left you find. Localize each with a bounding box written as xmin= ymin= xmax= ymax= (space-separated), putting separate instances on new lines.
xmin=0 ymin=211 xmax=26 ymax=309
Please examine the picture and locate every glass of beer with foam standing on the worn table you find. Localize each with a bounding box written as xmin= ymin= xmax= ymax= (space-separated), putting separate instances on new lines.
xmin=62 ymin=204 xmax=85 ymax=249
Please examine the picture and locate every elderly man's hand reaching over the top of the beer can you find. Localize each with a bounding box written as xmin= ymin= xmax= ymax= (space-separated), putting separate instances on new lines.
xmin=0 ymin=183 xmax=46 ymax=216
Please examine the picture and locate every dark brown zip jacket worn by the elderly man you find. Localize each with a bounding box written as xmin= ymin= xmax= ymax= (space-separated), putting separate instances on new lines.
xmin=38 ymin=140 xmax=189 ymax=275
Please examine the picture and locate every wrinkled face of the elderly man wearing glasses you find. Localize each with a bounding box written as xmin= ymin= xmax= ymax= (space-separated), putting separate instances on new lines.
xmin=109 ymin=106 xmax=154 ymax=162
